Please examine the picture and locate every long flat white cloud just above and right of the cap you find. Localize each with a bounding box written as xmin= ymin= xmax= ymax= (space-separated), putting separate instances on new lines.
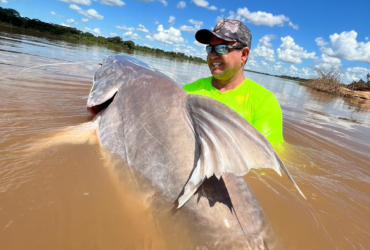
xmin=237 ymin=7 xmax=298 ymax=29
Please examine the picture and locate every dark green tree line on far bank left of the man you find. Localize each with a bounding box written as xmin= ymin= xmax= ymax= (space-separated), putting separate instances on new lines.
xmin=0 ymin=7 xmax=205 ymax=63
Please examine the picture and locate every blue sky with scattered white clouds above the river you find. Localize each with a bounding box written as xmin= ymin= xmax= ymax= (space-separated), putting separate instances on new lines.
xmin=0 ymin=0 xmax=370 ymax=83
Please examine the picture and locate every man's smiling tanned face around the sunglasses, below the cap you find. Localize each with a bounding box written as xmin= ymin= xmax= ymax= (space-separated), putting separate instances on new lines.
xmin=207 ymin=36 xmax=244 ymax=82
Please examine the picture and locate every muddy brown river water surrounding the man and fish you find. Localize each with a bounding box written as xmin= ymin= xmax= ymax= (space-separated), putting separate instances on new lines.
xmin=0 ymin=28 xmax=370 ymax=250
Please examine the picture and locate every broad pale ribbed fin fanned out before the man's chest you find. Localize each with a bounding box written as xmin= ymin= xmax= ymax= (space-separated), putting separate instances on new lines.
xmin=178 ymin=95 xmax=304 ymax=207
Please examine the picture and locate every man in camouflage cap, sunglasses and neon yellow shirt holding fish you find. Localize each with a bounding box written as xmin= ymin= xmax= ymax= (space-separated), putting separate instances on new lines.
xmin=184 ymin=19 xmax=284 ymax=143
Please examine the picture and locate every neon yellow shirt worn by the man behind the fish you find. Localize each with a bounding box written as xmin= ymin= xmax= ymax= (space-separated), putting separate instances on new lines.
xmin=183 ymin=77 xmax=284 ymax=143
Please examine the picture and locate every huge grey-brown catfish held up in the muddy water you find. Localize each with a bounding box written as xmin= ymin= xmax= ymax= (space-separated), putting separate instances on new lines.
xmin=87 ymin=55 xmax=300 ymax=249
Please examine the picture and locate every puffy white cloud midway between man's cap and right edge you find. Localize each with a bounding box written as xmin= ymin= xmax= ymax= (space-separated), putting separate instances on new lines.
xmin=277 ymin=36 xmax=316 ymax=63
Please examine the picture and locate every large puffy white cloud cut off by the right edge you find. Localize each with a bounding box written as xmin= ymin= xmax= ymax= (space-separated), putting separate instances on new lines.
xmin=315 ymin=30 xmax=370 ymax=63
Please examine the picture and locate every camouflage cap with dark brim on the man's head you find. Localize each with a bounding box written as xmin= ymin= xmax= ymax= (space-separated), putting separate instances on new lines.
xmin=195 ymin=19 xmax=252 ymax=48
